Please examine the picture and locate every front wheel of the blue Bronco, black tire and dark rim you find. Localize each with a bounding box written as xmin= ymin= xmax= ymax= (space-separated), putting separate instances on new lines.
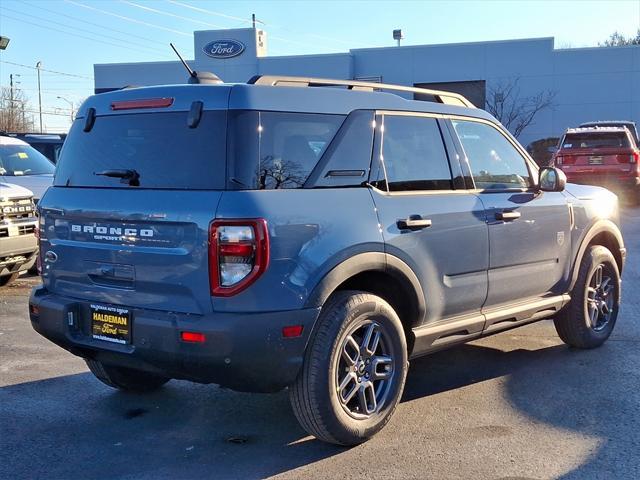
xmin=554 ymin=245 xmax=620 ymax=348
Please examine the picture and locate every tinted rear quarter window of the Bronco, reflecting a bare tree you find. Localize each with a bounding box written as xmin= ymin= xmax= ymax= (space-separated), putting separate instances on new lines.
xmin=229 ymin=111 xmax=345 ymax=190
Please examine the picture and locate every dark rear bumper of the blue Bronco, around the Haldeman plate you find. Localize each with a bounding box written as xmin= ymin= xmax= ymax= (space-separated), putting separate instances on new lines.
xmin=29 ymin=287 xmax=319 ymax=392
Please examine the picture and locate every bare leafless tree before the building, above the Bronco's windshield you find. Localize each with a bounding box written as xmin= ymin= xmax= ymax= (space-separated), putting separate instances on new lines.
xmin=486 ymin=77 xmax=556 ymax=137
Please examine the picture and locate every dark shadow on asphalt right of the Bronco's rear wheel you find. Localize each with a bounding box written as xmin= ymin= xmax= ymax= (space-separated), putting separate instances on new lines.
xmin=403 ymin=340 xmax=640 ymax=480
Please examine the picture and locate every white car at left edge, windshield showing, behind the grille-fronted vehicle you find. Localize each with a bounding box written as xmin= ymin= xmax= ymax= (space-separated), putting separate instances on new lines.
xmin=0 ymin=136 xmax=55 ymax=203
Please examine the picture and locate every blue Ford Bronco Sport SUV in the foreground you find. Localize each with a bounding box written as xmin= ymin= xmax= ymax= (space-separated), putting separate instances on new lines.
xmin=29 ymin=76 xmax=626 ymax=445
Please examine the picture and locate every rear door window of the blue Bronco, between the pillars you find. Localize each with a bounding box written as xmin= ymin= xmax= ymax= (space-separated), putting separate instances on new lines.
xmin=381 ymin=115 xmax=453 ymax=192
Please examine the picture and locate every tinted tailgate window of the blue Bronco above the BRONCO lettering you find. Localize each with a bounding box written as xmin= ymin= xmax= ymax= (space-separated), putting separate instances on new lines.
xmin=54 ymin=111 xmax=226 ymax=190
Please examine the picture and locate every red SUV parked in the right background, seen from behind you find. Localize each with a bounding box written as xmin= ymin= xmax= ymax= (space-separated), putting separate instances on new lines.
xmin=554 ymin=126 xmax=640 ymax=202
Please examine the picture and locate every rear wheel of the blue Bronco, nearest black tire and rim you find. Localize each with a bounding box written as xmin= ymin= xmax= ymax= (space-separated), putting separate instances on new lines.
xmin=289 ymin=291 xmax=408 ymax=446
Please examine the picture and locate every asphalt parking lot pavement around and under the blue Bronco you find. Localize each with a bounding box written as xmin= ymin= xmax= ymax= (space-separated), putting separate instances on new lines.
xmin=0 ymin=209 xmax=640 ymax=479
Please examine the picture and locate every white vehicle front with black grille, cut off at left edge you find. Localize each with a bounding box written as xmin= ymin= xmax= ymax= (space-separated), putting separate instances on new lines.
xmin=0 ymin=182 xmax=38 ymax=287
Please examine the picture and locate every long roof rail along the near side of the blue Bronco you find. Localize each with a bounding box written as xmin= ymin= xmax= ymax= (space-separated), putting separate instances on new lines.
xmin=247 ymin=75 xmax=476 ymax=108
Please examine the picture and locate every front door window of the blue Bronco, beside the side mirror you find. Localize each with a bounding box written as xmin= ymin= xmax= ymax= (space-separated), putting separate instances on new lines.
xmin=452 ymin=120 xmax=533 ymax=190
